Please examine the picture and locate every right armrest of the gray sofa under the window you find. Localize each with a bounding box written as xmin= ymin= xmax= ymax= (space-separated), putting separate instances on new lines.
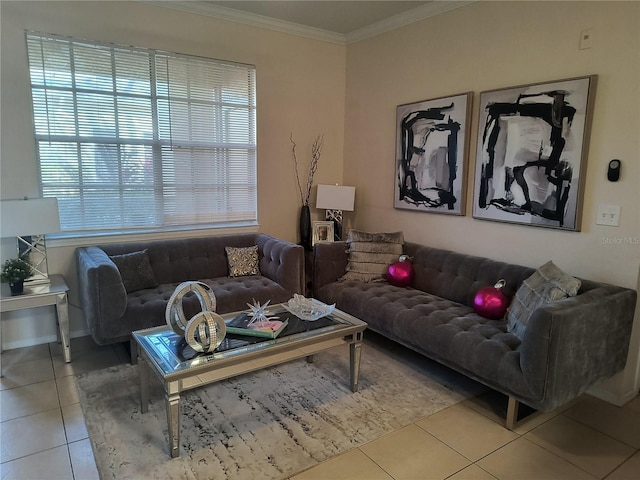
xmin=257 ymin=234 xmax=304 ymax=297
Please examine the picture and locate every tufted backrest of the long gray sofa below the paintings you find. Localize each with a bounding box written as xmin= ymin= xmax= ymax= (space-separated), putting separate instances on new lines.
xmin=404 ymin=242 xmax=535 ymax=307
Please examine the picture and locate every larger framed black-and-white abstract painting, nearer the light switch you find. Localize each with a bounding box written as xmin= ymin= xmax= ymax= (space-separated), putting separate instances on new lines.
xmin=473 ymin=75 xmax=597 ymax=231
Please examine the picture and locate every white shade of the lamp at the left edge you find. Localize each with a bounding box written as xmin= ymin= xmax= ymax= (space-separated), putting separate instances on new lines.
xmin=0 ymin=198 xmax=60 ymax=238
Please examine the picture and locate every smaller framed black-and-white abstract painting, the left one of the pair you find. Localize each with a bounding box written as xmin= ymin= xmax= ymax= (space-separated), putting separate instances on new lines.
xmin=393 ymin=92 xmax=473 ymax=215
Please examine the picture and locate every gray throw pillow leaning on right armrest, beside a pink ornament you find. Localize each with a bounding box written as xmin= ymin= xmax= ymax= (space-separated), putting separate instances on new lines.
xmin=507 ymin=261 xmax=582 ymax=340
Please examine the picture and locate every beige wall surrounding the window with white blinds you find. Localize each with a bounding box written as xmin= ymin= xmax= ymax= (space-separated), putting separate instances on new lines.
xmin=0 ymin=1 xmax=346 ymax=346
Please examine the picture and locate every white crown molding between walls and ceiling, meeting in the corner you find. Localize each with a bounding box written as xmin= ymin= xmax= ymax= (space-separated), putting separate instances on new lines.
xmin=144 ymin=0 xmax=477 ymax=45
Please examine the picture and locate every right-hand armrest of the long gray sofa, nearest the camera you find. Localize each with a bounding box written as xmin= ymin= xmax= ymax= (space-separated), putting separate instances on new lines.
xmin=520 ymin=282 xmax=637 ymax=410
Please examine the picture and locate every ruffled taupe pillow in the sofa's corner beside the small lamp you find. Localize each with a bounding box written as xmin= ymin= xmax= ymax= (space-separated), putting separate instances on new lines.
xmin=340 ymin=230 xmax=404 ymax=282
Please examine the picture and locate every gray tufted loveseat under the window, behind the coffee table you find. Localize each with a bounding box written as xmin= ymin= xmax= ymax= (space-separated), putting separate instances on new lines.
xmin=76 ymin=234 xmax=304 ymax=345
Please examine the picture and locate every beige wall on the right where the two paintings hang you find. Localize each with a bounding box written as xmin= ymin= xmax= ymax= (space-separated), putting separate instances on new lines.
xmin=344 ymin=1 xmax=640 ymax=404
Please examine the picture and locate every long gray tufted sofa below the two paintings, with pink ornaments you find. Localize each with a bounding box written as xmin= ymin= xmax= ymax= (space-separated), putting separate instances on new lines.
xmin=313 ymin=242 xmax=636 ymax=428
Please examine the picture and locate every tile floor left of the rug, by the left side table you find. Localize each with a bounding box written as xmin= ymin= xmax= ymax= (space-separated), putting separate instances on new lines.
xmin=0 ymin=337 xmax=129 ymax=480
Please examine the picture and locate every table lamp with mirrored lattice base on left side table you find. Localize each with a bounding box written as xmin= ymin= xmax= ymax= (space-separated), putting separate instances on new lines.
xmin=0 ymin=198 xmax=60 ymax=285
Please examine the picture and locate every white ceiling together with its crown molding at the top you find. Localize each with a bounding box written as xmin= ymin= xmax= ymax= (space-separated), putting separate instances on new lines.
xmin=151 ymin=0 xmax=475 ymax=44
